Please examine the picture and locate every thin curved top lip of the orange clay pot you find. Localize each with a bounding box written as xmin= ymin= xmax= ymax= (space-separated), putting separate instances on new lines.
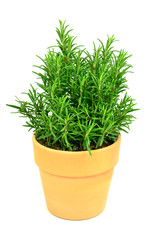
xmin=32 ymin=134 xmax=121 ymax=155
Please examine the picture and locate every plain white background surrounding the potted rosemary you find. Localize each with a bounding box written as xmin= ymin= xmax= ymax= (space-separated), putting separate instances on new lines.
xmin=0 ymin=0 xmax=154 ymax=240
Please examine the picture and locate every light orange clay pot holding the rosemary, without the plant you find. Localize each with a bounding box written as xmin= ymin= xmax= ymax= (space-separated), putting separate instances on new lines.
xmin=33 ymin=135 xmax=121 ymax=220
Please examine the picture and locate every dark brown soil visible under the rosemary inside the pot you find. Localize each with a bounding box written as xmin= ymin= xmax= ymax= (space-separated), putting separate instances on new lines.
xmin=37 ymin=139 xmax=114 ymax=151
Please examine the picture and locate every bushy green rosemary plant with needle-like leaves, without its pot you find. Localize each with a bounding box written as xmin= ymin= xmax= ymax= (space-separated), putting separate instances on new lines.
xmin=7 ymin=21 xmax=137 ymax=154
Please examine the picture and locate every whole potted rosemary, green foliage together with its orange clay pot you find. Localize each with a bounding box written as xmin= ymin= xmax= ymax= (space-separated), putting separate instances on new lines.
xmin=7 ymin=21 xmax=137 ymax=220
